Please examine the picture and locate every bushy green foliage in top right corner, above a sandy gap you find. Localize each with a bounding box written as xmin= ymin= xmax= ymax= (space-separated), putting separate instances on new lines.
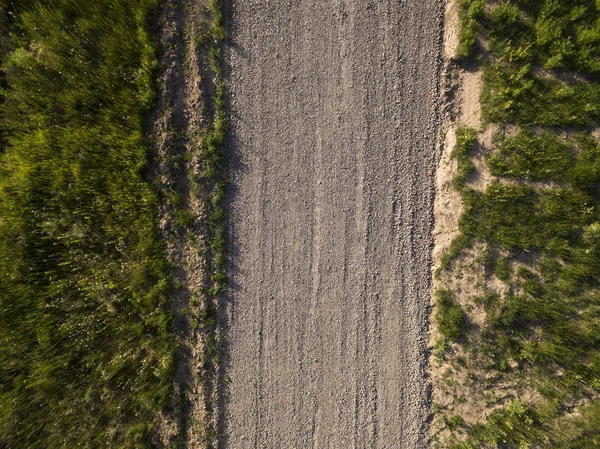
xmin=484 ymin=0 xmax=600 ymax=126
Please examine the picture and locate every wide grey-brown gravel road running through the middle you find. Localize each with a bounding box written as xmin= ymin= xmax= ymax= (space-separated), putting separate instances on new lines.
xmin=220 ymin=0 xmax=443 ymax=449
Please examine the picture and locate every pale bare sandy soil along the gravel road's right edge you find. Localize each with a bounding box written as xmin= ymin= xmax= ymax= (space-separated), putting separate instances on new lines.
xmin=429 ymin=0 xmax=504 ymax=447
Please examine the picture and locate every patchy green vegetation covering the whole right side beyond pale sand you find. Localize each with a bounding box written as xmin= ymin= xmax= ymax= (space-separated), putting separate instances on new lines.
xmin=438 ymin=0 xmax=600 ymax=449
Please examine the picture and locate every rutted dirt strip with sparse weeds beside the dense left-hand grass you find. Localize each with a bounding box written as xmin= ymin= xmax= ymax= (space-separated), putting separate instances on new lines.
xmin=148 ymin=0 xmax=224 ymax=448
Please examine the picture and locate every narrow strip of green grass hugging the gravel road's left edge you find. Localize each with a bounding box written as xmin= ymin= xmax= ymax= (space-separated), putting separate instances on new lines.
xmin=197 ymin=0 xmax=228 ymax=447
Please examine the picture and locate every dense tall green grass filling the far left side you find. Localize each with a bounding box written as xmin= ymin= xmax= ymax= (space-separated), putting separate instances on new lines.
xmin=0 ymin=0 xmax=174 ymax=449
